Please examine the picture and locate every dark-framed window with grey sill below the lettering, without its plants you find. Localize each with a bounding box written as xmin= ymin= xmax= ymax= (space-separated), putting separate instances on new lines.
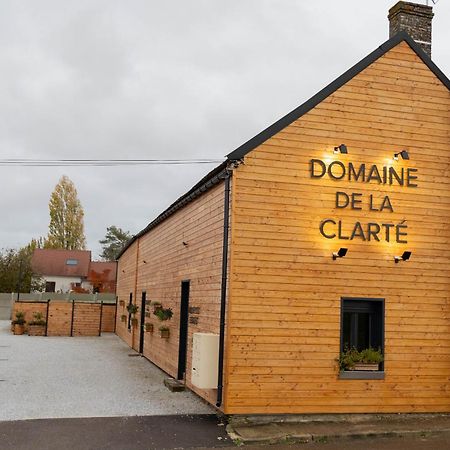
xmin=339 ymin=298 xmax=384 ymax=380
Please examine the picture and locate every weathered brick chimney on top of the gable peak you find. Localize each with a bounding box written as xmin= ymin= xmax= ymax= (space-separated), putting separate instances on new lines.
xmin=388 ymin=2 xmax=434 ymax=58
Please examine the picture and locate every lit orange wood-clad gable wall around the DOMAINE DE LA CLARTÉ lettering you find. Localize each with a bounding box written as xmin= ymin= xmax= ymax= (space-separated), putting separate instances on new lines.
xmin=225 ymin=42 xmax=450 ymax=414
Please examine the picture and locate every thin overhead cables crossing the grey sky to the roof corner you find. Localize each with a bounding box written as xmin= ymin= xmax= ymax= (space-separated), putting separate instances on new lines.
xmin=0 ymin=158 xmax=223 ymax=167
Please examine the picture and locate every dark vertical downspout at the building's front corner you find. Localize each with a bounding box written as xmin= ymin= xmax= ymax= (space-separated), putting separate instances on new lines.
xmin=216 ymin=170 xmax=231 ymax=407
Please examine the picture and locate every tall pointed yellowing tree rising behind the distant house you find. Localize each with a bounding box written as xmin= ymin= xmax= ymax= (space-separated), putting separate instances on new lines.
xmin=45 ymin=175 xmax=86 ymax=250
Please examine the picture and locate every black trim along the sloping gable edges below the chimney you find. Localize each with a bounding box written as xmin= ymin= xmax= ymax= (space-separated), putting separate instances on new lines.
xmin=227 ymin=31 xmax=450 ymax=161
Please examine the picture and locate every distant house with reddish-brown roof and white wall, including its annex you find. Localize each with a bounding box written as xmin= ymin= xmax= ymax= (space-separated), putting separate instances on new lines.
xmin=31 ymin=249 xmax=116 ymax=293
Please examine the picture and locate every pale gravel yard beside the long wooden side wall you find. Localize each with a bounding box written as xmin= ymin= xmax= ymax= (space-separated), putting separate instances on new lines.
xmin=0 ymin=321 xmax=215 ymax=421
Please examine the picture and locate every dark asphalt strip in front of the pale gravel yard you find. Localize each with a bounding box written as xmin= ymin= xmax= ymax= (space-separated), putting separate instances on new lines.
xmin=0 ymin=415 xmax=233 ymax=450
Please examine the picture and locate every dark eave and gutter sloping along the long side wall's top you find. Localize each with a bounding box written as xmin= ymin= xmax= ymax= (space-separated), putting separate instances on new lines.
xmin=116 ymin=161 xmax=228 ymax=261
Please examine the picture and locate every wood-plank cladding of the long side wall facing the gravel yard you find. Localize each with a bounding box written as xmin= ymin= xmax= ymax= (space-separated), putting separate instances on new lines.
xmin=117 ymin=183 xmax=224 ymax=403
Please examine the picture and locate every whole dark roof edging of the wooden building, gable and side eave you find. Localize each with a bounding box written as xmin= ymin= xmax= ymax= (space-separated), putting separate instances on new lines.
xmin=117 ymin=31 xmax=450 ymax=259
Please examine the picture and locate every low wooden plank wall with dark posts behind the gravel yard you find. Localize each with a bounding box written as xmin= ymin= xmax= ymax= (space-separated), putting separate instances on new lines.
xmin=13 ymin=300 xmax=116 ymax=336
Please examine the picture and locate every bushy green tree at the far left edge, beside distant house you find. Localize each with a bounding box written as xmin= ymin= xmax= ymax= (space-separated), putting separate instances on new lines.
xmin=0 ymin=244 xmax=45 ymax=292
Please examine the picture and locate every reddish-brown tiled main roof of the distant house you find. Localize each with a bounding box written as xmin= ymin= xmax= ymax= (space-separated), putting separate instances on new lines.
xmin=31 ymin=248 xmax=91 ymax=277
